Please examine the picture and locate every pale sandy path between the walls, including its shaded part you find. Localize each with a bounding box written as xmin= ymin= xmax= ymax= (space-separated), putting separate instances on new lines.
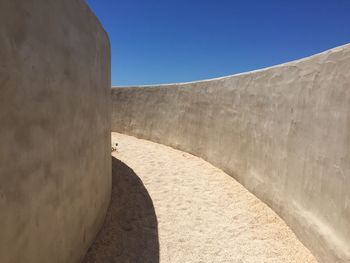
xmin=84 ymin=133 xmax=317 ymax=263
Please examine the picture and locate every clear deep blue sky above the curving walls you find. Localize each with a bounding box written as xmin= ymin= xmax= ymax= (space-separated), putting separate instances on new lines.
xmin=86 ymin=0 xmax=350 ymax=86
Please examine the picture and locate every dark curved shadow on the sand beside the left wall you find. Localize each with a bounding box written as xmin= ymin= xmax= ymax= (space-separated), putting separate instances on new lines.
xmin=82 ymin=157 xmax=159 ymax=263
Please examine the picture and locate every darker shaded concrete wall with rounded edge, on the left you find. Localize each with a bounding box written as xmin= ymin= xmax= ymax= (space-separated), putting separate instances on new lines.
xmin=0 ymin=0 xmax=111 ymax=263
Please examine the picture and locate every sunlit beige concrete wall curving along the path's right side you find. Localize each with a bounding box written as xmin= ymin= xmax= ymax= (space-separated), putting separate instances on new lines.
xmin=112 ymin=45 xmax=350 ymax=262
